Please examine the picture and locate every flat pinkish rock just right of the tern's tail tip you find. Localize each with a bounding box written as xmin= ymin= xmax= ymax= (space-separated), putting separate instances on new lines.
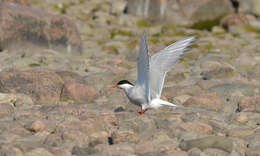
xmin=183 ymin=92 xmax=225 ymax=111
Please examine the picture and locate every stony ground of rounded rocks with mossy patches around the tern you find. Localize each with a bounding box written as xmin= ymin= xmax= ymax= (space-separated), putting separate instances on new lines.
xmin=0 ymin=0 xmax=260 ymax=156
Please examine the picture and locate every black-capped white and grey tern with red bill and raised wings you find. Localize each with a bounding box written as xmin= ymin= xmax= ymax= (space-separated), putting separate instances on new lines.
xmin=111 ymin=32 xmax=197 ymax=115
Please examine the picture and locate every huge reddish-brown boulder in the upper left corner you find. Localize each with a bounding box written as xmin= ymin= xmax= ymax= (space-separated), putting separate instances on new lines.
xmin=0 ymin=1 xmax=81 ymax=52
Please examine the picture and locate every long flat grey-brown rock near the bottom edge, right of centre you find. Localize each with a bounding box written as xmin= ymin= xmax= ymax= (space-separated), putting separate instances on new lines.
xmin=180 ymin=136 xmax=233 ymax=153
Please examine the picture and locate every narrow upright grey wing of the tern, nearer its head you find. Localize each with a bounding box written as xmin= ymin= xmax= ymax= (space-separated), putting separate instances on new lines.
xmin=136 ymin=32 xmax=150 ymax=102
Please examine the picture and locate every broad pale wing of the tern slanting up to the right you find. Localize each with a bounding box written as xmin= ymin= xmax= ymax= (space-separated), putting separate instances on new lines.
xmin=150 ymin=36 xmax=196 ymax=99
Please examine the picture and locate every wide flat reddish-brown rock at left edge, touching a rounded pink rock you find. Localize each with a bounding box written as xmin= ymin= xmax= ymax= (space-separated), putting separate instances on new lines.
xmin=0 ymin=70 xmax=63 ymax=104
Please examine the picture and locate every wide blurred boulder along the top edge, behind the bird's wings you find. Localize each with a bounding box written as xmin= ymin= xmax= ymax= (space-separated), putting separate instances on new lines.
xmin=127 ymin=0 xmax=234 ymax=26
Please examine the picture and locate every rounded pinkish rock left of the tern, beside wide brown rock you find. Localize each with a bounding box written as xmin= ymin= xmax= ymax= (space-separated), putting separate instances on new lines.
xmin=61 ymin=83 xmax=98 ymax=102
